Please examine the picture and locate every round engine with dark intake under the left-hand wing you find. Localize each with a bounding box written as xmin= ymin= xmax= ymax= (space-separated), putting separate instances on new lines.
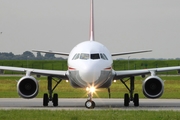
xmin=17 ymin=76 xmax=39 ymax=99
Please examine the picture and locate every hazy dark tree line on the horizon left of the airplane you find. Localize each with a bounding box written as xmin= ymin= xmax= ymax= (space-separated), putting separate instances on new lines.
xmin=0 ymin=51 xmax=65 ymax=60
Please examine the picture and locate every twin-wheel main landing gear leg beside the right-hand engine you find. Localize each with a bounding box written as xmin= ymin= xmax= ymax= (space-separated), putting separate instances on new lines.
xmin=121 ymin=76 xmax=139 ymax=106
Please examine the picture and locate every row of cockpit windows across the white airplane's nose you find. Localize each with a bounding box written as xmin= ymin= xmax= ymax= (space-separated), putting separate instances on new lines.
xmin=72 ymin=53 xmax=108 ymax=60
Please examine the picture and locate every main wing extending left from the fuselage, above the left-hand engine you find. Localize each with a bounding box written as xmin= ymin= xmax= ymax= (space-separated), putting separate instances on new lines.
xmin=0 ymin=66 xmax=68 ymax=79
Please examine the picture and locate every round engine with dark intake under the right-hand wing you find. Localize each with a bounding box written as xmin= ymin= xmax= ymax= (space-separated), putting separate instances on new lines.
xmin=142 ymin=76 xmax=164 ymax=98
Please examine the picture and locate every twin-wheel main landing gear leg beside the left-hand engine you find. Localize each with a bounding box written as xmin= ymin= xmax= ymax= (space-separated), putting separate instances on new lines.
xmin=43 ymin=76 xmax=62 ymax=107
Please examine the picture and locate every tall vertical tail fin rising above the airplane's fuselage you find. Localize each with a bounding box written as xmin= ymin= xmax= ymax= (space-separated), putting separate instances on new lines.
xmin=90 ymin=0 xmax=94 ymax=41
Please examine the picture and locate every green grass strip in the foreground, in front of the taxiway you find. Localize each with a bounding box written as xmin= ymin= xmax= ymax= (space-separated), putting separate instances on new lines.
xmin=0 ymin=110 xmax=180 ymax=120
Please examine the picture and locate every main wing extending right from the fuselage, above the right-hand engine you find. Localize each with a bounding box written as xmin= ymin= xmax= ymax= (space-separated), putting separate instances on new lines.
xmin=114 ymin=66 xmax=180 ymax=79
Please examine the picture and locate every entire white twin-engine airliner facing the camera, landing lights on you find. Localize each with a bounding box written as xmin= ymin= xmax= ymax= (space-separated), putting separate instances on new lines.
xmin=0 ymin=0 xmax=180 ymax=109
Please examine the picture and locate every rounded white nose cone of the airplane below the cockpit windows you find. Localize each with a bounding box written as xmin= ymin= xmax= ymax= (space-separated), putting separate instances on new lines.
xmin=79 ymin=65 xmax=101 ymax=83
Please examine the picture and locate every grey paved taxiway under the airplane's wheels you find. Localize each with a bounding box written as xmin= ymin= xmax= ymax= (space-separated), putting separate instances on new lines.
xmin=0 ymin=98 xmax=180 ymax=111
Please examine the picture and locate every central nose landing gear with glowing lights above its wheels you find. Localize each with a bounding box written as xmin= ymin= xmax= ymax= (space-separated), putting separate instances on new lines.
xmin=85 ymin=88 xmax=96 ymax=109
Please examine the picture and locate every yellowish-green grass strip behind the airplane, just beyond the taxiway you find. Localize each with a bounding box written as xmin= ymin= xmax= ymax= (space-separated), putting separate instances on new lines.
xmin=0 ymin=76 xmax=180 ymax=99
